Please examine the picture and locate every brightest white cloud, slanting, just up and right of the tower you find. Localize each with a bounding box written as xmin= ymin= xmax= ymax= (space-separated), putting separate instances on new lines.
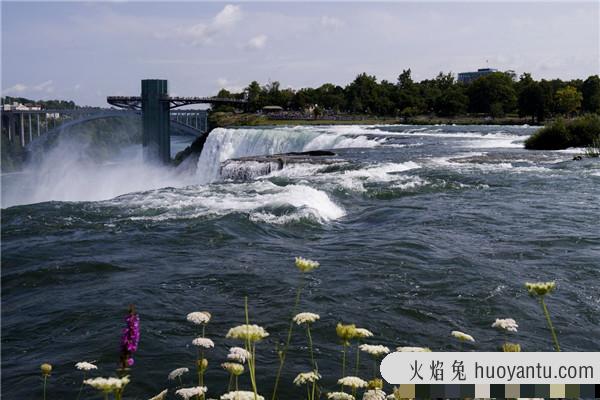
xmin=176 ymin=4 xmax=242 ymax=46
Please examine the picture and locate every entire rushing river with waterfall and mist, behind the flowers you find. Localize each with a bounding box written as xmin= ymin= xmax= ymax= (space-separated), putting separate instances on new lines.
xmin=2 ymin=126 xmax=600 ymax=399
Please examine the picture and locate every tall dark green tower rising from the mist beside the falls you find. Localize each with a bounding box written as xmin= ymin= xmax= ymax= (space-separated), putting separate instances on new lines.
xmin=142 ymin=79 xmax=171 ymax=164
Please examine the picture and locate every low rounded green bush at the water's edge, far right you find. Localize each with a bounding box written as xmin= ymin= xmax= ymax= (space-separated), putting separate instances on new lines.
xmin=525 ymin=114 xmax=600 ymax=150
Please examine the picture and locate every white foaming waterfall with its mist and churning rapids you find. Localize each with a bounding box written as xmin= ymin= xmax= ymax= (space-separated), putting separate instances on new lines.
xmin=2 ymin=126 xmax=576 ymax=223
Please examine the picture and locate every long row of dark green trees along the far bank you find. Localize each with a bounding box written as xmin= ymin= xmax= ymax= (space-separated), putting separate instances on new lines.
xmin=218 ymin=69 xmax=600 ymax=122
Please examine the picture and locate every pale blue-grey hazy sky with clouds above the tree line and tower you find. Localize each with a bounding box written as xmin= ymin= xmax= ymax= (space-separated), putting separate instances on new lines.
xmin=1 ymin=1 xmax=600 ymax=106
